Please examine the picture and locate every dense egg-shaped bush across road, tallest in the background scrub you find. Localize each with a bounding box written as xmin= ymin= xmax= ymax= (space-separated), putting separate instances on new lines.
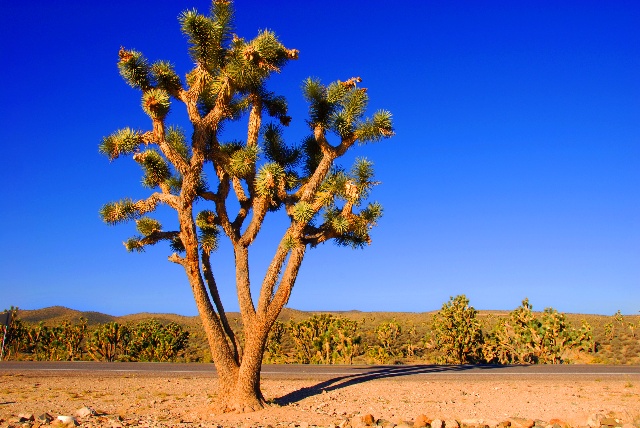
xmin=432 ymin=294 xmax=483 ymax=364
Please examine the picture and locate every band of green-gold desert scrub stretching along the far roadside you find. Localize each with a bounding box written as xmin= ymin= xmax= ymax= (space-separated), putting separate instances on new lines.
xmin=3 ymin=296 xmax=640 ymax=364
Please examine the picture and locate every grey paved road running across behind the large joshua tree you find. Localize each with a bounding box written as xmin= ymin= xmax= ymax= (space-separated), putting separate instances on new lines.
xmin=0 ymin=361 xmax=640 ymax=381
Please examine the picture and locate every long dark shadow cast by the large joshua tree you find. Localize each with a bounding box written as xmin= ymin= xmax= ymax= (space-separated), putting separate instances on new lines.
xmin=274 ymin=364 xmax=504 ymax=406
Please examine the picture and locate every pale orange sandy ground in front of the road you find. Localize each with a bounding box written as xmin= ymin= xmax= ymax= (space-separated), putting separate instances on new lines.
xmin=0 ymin=374 xmax=640 ymax=427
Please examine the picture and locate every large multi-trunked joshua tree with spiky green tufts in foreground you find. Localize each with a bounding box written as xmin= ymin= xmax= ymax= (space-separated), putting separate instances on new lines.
xmin=100 ymin=0 xmax=393 ymax=411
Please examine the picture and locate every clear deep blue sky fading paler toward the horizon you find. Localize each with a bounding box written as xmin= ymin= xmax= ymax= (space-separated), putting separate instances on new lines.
xmin=0 ymin=0 xmax=640 ymax=315
